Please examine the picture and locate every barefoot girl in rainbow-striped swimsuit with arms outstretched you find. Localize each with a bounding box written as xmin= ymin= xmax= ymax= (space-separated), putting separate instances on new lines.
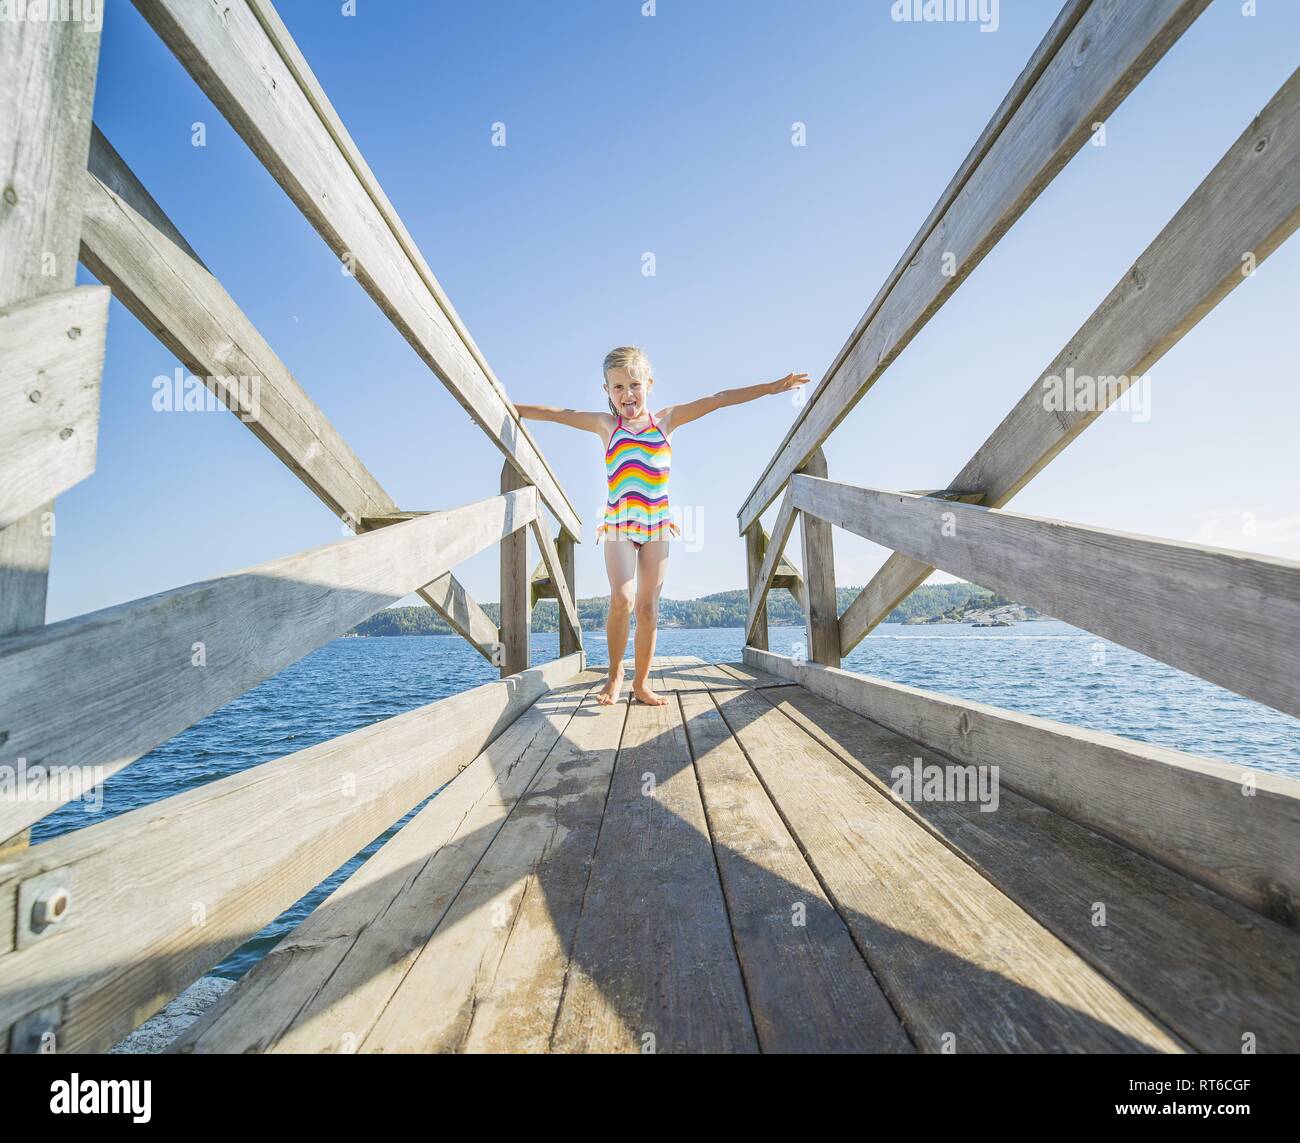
xmin=516 ymin=346 xmax=809 ymax=706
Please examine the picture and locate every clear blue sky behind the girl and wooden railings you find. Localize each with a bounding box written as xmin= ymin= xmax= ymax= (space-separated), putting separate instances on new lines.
xmin=58 ymin=0 xmax=1300 ymax=620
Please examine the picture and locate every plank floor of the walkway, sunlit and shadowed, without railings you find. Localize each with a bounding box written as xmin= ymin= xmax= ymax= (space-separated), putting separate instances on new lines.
xmin=173 ymin=659 xmax=1300 ymax=1052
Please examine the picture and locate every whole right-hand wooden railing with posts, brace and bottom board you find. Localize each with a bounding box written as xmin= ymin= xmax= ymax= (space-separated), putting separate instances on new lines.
xmin=738 ymin=0 xmax=1300 ymax=927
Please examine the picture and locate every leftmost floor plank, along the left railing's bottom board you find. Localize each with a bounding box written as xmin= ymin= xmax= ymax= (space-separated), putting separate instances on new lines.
xmin=170 ymin=675 xmax=597 ymax=1053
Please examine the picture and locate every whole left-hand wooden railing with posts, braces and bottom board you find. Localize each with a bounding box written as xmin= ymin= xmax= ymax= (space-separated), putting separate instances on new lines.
xmin=0 ymin=0 xmax=584 ymax=1051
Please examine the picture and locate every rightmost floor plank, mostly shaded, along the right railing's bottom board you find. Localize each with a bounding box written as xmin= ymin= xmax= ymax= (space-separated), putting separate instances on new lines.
xmin=759 ymin=687 xmax=1300 ymax=1053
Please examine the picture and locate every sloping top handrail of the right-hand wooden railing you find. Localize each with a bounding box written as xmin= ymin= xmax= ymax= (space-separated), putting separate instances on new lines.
xmin=738 ymin=0 xmax=1209 ymax=533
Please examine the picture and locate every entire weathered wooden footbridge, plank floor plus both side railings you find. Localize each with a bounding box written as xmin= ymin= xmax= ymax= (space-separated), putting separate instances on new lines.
xmin=0 ymin=0 xmax=1300 ymax=1053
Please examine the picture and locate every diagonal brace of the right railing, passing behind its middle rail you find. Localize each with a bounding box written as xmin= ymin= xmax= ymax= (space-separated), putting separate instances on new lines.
xmin=840 ymin=73 xmax=1300 ymax=654
